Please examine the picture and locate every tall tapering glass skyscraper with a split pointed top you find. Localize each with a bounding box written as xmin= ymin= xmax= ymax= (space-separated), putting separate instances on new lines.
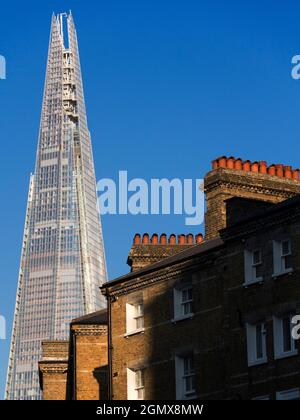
xmin=5 ymin=14 xmax=106 ymax=399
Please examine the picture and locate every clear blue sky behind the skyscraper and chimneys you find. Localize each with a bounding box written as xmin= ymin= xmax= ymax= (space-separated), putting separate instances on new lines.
xmin=0 ymin=0 xmax=300 ymax=396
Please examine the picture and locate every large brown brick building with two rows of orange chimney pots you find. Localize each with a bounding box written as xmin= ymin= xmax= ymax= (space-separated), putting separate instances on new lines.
xmin=40 ymin=157 xmax=300 ymax=400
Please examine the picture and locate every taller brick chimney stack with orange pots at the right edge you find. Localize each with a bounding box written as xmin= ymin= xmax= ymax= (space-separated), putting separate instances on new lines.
xmin=204 ymin=157 xmax=300 ymax=239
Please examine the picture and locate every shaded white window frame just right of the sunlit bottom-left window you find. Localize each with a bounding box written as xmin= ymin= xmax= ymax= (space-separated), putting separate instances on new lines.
xmin=175 ymin=353 xmax=196 ymax=401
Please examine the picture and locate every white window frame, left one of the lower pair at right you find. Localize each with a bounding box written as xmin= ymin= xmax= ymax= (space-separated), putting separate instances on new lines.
xmin=246 ymin=322 xmax=268 ymax=366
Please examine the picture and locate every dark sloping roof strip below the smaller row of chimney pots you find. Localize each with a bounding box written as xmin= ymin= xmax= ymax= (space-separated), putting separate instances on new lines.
xmin=101 ymin=238 xmax=224 ymax=289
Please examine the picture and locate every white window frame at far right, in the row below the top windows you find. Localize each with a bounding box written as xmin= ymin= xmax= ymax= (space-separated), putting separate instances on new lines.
xmin=273 ymin=314 xmax=298 ymax=359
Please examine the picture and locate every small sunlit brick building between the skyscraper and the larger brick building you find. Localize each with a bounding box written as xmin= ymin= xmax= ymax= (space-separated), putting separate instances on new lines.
xmin=39 ymin=310 xmax=108 ymax=400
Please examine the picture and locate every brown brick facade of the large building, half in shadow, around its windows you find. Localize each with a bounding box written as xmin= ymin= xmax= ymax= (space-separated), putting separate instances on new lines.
xmin=105 ymin=192 xmax=300 ymax=400
